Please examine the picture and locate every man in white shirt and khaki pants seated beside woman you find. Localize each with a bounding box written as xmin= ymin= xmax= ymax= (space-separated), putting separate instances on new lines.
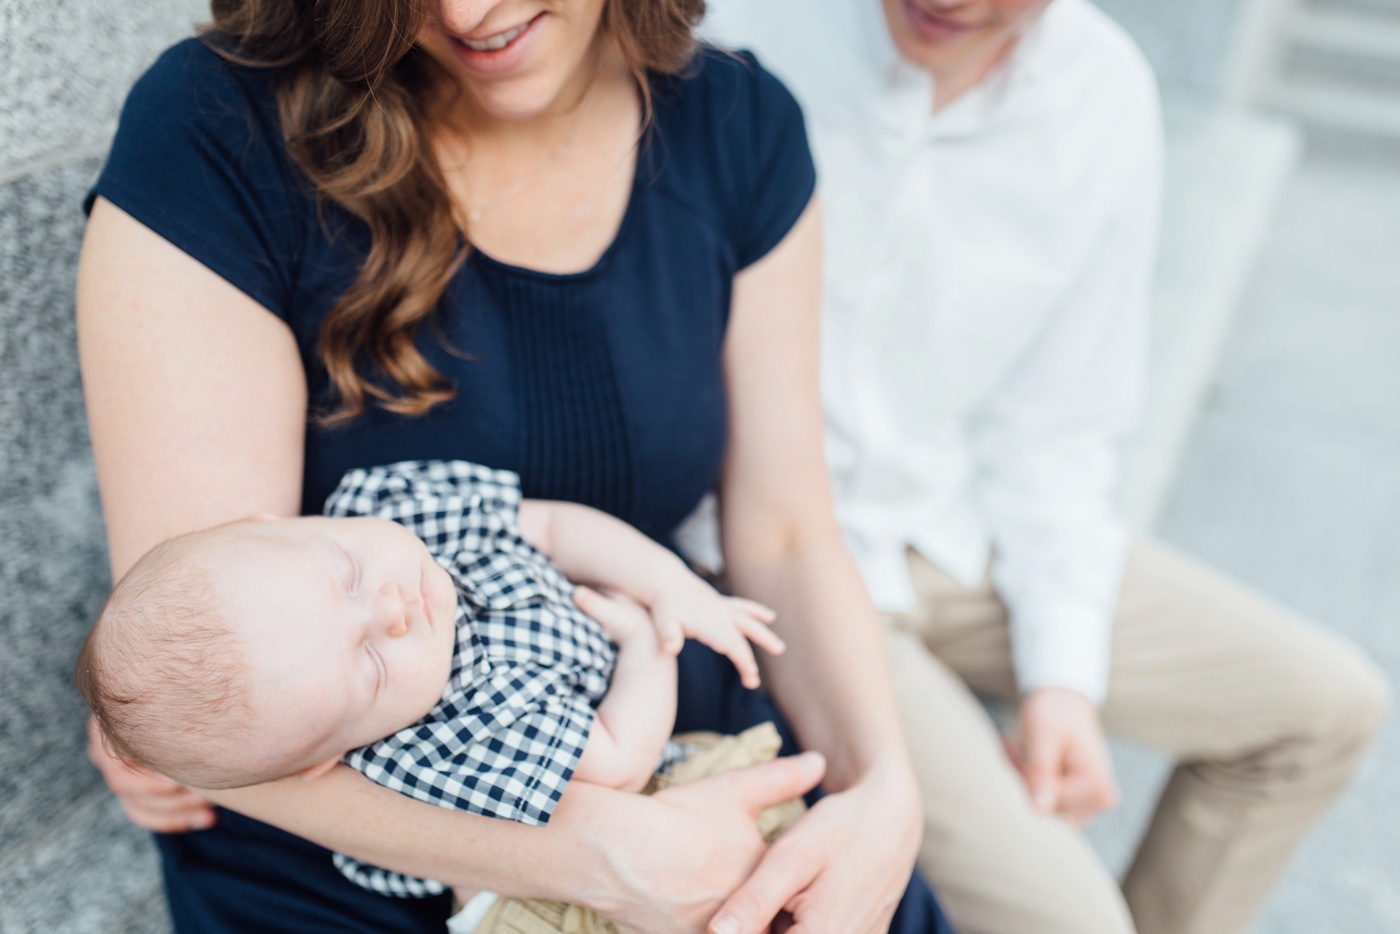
xmin=706 ymin=0 xmax=1387 ymax=934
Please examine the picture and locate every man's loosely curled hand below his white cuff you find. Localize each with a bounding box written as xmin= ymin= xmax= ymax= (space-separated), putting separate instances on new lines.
xmin=1012 ymin=688 xmax=1119 ymax=828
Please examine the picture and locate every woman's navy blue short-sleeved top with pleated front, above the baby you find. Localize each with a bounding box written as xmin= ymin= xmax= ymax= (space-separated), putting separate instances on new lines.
xmin=88 ymin=39 xmax=815 ymax=538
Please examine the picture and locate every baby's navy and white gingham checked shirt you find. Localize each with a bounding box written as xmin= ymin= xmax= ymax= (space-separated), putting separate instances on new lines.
xmin=326 ymin=461 xmax=616 ymax=898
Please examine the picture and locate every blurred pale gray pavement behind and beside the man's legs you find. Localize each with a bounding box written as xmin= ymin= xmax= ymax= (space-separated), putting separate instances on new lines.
xmin=1091 ymin=149 xmax=1400 ymax=934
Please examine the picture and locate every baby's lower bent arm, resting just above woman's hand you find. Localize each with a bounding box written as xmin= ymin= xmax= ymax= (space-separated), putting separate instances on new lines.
xmin=574 ymin=590 xmax=676 ymax=791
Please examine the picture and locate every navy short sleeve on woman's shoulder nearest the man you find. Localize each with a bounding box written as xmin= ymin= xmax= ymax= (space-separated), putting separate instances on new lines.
xmin=731 ymin=52 xmax=816 ymax=269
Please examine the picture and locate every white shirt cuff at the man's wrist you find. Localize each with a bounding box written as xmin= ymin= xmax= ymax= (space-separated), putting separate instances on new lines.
xmin=1011 ymin=601 xmax=1113 ymax=704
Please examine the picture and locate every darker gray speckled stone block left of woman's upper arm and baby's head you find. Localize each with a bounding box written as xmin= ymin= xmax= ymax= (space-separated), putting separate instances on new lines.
xmin=0 ymin=161 xmax=108 ymax=856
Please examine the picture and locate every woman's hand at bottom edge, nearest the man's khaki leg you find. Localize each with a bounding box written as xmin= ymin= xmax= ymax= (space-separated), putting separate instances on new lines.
xmin=708 ymin=769 xmax=921 ymax=934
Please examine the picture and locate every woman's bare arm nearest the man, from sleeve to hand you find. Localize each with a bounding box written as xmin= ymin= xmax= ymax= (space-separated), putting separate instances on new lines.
xmin=714 ymin=199 xmax=920 ymax=934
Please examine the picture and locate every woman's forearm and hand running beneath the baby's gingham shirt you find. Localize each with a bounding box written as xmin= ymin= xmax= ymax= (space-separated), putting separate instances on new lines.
xmin=209 ymin=756 xmax=820 ymax=934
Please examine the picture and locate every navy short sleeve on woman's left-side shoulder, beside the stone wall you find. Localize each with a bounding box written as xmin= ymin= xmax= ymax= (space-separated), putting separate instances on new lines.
xmin=84 ymin=39 xmax=314 ymax=319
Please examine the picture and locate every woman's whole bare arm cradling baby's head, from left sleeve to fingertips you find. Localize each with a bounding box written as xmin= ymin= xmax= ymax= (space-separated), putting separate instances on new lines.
xmin=78 ymin=200 xmax=819 ymax=934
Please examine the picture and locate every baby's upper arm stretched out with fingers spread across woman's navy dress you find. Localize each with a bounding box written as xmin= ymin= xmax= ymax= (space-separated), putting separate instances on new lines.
xmin=519 ymin=500 xmax=784 ymax=688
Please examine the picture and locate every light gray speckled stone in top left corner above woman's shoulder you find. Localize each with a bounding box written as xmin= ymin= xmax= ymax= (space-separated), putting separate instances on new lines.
xmin=0 ymin=0 xmax=209 ymax=178
